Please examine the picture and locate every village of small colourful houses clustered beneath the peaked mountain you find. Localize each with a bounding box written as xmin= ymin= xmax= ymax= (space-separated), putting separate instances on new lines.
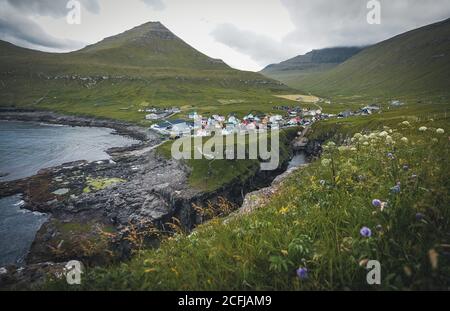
xmin=145 ymin=105 xmax=380 ymax=139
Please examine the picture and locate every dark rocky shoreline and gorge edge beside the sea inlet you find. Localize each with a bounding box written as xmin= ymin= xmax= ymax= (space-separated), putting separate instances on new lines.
xmin=0 ymin=110 xmax=310 ymax=288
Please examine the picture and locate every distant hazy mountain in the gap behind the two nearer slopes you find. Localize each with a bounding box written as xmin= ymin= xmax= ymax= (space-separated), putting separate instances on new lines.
xmin=261 ymin=47 xmax=363 ymax=87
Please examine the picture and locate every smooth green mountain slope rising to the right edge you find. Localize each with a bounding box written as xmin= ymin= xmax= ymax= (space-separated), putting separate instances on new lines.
xmin=288 ymin=19 xmax=450 ymax=96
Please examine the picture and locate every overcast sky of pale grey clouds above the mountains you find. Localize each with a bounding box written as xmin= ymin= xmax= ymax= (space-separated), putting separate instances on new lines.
xmin=0 ymin=0 xmax=450 ymax=71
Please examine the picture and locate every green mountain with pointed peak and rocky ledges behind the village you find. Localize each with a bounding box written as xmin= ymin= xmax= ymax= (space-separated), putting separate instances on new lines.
xmin=0 ymin=22 xmax=290 ymax=121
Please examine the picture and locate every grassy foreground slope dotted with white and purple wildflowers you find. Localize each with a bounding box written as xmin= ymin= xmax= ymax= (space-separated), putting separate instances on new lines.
xmin=47 ymin=98 xmax=450 ymax=290
